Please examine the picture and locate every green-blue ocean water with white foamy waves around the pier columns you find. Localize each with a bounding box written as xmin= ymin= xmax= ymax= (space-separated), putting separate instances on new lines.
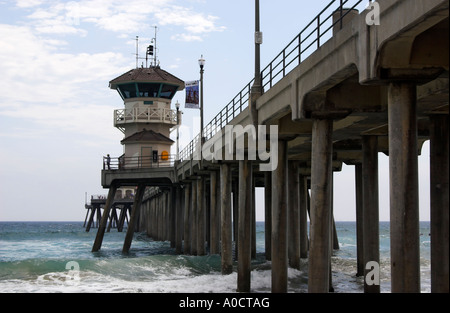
xmin=0 ymin=222 xmax=431 ymax=293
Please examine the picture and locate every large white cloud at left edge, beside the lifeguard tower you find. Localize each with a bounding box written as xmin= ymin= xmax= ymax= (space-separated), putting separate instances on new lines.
xmin=0 ymin=24 xmax=128 ymax=138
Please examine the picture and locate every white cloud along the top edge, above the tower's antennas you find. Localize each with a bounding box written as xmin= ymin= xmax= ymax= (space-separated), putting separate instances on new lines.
xmin=16 ymin=0 xmax=225 ymax=41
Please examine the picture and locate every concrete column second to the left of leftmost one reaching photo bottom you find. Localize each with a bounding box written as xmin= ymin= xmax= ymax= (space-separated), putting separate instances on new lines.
xmin=210 ymin=171 xmax=220 ymax=254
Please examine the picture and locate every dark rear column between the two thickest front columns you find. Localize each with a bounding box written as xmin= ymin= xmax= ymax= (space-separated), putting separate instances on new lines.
xmin=362 ymin=136 xmax=380 ymax=293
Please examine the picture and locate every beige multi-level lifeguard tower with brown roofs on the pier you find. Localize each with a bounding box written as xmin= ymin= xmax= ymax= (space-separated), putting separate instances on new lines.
xmin=109 ymin=65 xmax=185 ymax=169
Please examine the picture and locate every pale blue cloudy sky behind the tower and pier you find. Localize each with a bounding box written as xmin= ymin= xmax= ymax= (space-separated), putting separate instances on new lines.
xmin=0 ymin=0 xmax=429 ymax=221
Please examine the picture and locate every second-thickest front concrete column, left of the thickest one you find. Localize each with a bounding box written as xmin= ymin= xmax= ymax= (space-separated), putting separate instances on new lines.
xmin=308 ymin=119 xmax=333 ymax=293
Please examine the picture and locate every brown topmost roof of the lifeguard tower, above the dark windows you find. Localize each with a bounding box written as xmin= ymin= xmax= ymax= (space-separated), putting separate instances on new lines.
xmin=109 ymin=66 xmax=184 ymax=91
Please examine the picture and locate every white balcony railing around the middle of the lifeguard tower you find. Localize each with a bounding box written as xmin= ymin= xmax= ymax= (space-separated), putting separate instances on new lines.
xmin=114 ymin=107 xmax=178 ymax=128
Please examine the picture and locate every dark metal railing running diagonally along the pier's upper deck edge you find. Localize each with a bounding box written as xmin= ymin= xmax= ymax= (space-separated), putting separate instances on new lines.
xmin=180 ymin=0 xmax=372 ymax=161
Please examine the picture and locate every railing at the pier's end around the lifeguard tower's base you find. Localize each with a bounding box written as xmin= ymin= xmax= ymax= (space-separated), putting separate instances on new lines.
xmin=103 ymin=154 xmax=176 ymax=171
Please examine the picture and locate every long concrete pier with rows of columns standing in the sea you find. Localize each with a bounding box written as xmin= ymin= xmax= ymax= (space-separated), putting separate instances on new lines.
xmin=92 ymin=0 xmax=449 ymax=293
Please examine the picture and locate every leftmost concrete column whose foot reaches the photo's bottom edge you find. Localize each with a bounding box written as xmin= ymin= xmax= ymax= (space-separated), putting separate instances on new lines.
xmin=237 ymin=160 xmax=253 ymax=292
